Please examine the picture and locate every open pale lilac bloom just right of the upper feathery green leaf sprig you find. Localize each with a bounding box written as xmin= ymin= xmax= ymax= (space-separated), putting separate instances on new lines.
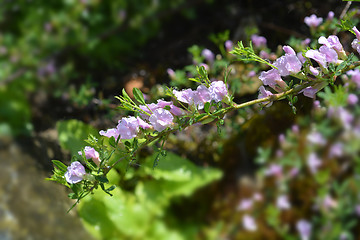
xmin=274 ymin=52 xmax=302 ymax=76
